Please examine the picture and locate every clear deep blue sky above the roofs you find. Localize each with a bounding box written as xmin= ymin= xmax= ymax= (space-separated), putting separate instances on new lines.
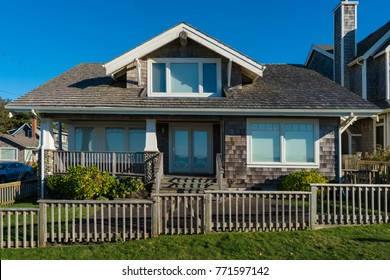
xmin=0 ymin=0 xmax=390 ymax=99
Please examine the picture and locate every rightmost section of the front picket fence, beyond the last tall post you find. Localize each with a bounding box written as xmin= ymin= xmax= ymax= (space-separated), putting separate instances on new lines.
xmin=311 ymin=184 xmax=390 ymax=228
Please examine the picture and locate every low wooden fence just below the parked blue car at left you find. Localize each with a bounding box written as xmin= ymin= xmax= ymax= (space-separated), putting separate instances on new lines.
xmin=0 ymin=179 xmax=38 ymax=206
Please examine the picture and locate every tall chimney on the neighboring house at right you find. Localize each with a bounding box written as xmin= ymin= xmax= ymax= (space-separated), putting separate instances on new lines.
xmin=333 ymin=0 xmax=359 ymax=89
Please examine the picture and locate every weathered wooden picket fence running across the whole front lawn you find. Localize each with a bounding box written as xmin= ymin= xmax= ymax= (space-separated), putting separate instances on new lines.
xmin=0 ymin=184 xmax=390 ymax=248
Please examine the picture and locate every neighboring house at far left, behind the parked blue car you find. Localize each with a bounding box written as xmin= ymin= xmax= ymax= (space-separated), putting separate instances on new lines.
xmin=0 ymin=120 xmax=67 ymax=163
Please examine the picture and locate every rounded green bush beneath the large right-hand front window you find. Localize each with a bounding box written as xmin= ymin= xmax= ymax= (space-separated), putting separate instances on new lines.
xmin=280 ymin=169 xmax=328 ymax=191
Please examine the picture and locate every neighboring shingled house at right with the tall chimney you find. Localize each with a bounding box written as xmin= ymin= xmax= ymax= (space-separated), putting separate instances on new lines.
xmin=305 ymin=1 xmax=390 ymax=154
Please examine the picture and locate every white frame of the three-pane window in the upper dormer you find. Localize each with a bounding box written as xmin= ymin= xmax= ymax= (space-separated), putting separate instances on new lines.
xmin=148 ymin=58 xmax=222 ymax=97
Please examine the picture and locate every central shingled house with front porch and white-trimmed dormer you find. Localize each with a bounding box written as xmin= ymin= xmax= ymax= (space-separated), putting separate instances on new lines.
xmin=7 ymin=23 xmax=380 ymax=188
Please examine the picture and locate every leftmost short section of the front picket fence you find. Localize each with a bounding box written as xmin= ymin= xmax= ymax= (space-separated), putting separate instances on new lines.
xmin=0 ymin=208 xmax=39 ymax=248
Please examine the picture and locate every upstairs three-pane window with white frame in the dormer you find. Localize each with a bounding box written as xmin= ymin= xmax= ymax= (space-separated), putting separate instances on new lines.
xmin=148 ymin=58 xmax=222 ymax=97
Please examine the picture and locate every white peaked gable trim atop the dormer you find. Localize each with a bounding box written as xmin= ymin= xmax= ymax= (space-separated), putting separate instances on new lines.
xmin=104 ymin=22 xmax=264 ymax=79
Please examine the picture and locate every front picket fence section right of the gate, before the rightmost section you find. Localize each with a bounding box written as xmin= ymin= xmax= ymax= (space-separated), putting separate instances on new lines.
xmin=206 ymin=191 xmax=311 ymax=231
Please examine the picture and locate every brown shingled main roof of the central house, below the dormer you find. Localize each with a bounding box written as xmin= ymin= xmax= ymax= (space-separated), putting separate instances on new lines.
xmin=7 ymin=63 xmax=380 ymax=116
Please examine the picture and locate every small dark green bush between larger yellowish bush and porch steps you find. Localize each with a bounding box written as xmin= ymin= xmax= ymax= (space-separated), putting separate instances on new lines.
xmin=111 ymin=177 xmax=147 ymax=198
